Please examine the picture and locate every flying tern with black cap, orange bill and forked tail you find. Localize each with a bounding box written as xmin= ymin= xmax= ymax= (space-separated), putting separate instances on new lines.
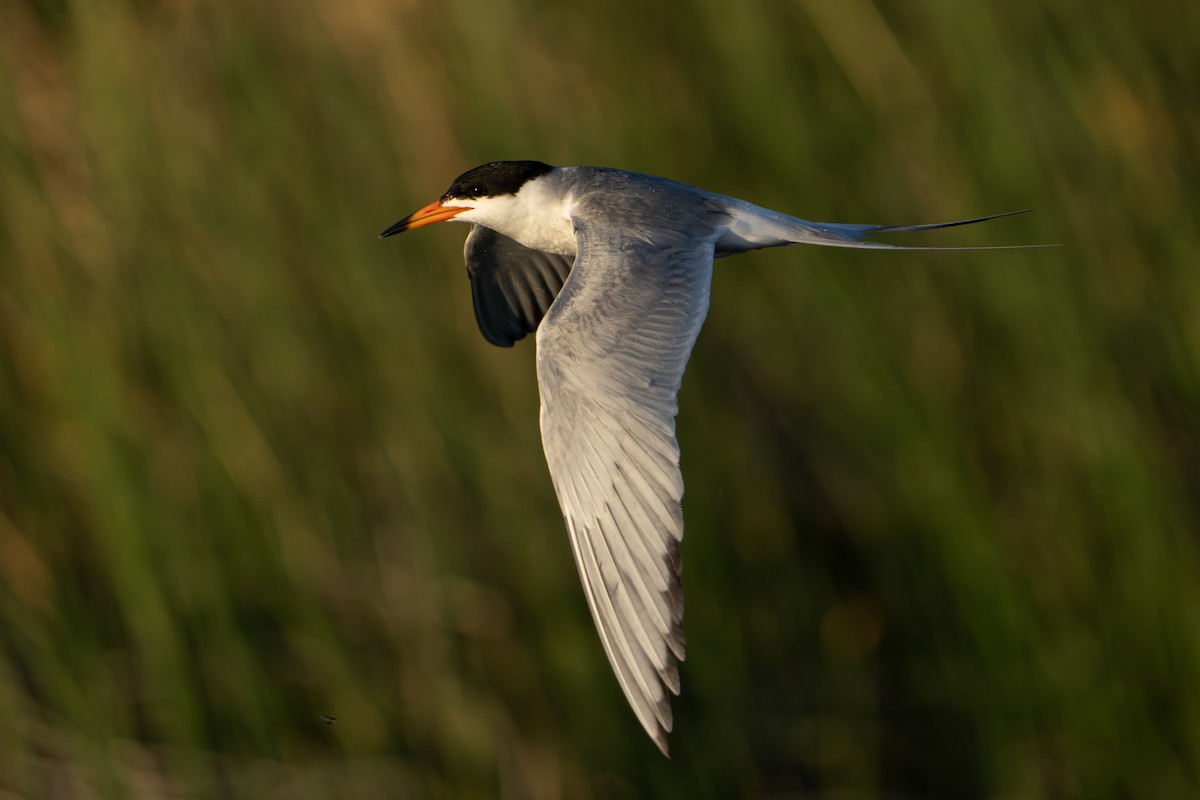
xmin=380 ymin=161 xmax=1037 ymax=756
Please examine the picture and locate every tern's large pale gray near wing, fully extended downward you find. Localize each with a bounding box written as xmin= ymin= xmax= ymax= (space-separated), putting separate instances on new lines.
xmin=538 ymin=195 xmax=719 ymax=753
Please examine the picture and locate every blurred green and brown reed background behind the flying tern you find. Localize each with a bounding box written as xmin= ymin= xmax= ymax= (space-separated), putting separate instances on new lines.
xmin=0 ymin=0 xmax=1200 ymax=800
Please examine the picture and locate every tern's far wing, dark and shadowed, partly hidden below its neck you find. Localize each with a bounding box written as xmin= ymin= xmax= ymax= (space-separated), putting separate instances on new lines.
xmin=463 ymin=225 xmax=571 ymax=347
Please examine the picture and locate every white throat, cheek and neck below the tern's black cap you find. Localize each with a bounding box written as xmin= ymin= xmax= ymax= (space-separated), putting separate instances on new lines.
xmin=445 ymin=173 xmax=576 ymax=255
